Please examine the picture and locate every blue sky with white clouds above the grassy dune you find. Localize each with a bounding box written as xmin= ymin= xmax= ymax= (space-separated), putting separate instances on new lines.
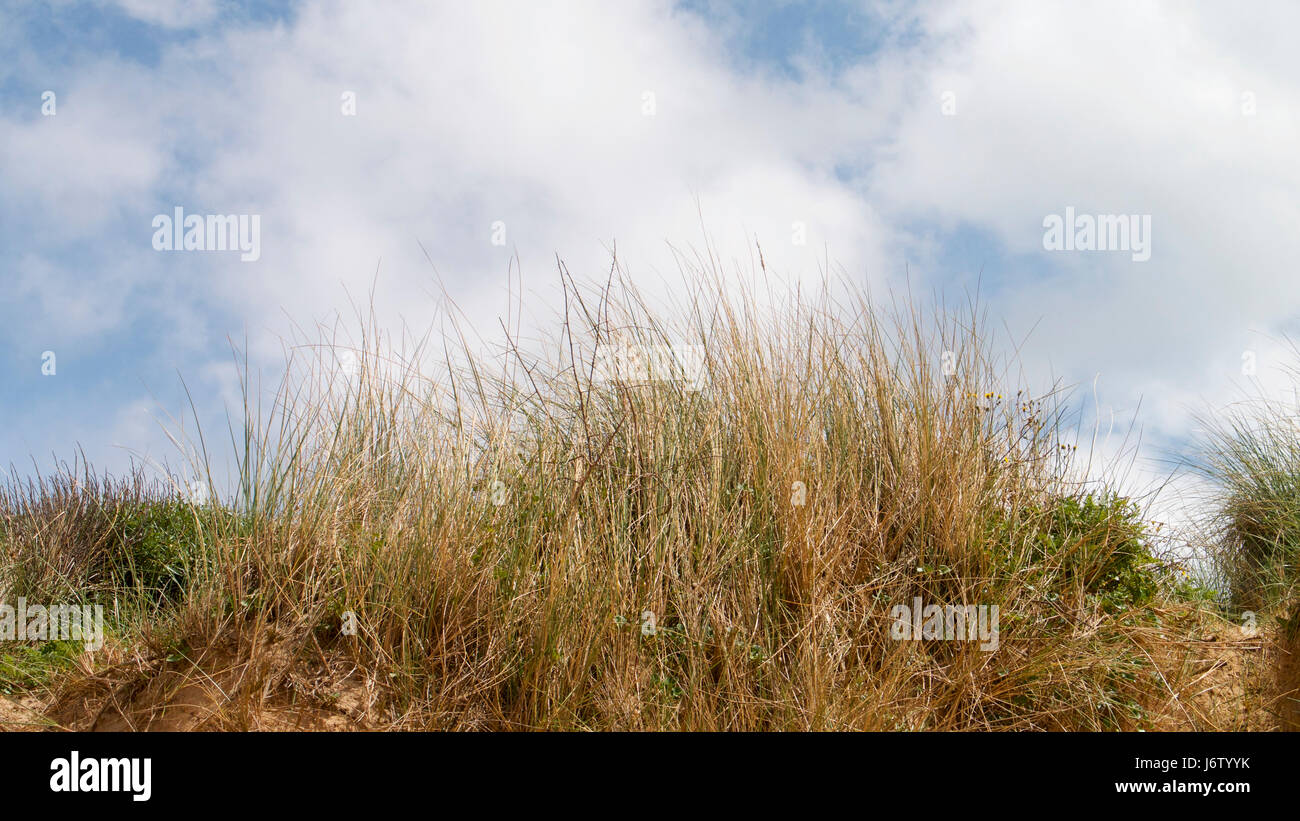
xmin=0 ymin=0 xmax=1300 ymax=535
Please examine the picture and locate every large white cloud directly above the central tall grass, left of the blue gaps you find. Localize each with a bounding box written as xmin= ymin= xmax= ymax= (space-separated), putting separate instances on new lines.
xmin=48 ymin=3 xmax=885 ymax=356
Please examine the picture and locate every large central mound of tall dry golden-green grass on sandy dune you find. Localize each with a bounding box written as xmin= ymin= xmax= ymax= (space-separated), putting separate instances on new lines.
xmin=0 ymin=258 xmax=1263 ymax=730
